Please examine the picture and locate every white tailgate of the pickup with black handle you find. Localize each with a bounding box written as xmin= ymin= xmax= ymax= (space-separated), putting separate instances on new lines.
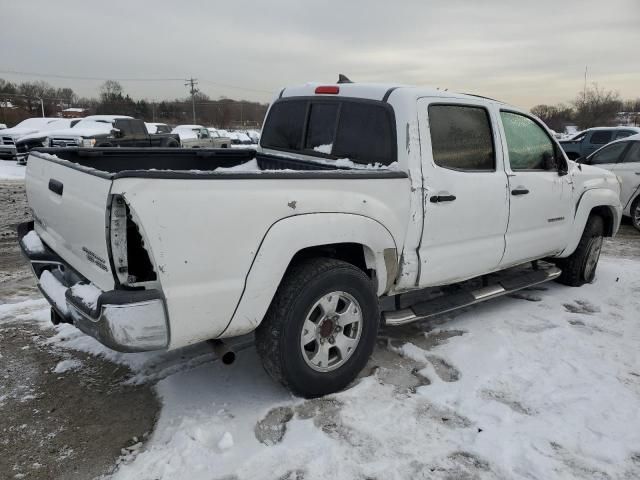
xmin=26 ymin=154 xmax=114 ymax=290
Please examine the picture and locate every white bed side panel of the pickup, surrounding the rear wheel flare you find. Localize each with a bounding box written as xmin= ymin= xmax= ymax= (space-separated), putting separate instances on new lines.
xmin=112 ymin=174 xmax=410 ymax=348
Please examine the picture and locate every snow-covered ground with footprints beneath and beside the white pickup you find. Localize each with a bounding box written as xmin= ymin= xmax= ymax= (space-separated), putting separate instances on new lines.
xmin=0 ymin=257 xmax=640 ymax=480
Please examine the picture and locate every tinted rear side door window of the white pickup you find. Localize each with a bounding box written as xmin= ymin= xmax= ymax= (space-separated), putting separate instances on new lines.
xmin=429 ymin=105 xmax=496 ymax=171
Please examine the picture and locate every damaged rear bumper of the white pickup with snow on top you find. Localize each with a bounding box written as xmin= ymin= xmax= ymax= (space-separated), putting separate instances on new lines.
xmin=18 ymin=222 xmax=169 ymax=352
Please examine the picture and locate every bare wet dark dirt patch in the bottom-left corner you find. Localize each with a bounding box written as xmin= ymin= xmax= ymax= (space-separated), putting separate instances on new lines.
xmin=0 ymin=323 xmax=159 ymax=479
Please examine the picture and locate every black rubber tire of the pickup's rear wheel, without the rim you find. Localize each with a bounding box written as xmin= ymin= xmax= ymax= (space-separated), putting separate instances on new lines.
xmin=255 ymin=258 xmax=380 ymax=398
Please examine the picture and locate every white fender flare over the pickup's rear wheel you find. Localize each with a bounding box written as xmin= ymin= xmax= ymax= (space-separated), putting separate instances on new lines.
xmin=220 ymin=213 xmax=398 ymax=337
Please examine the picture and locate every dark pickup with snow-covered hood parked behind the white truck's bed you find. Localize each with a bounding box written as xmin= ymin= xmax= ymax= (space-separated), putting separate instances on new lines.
xmin=47 ymin=115 xmax=180 ymax=147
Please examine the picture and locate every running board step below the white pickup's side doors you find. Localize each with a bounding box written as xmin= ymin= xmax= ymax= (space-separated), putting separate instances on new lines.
xmin=383 ymin=267 xmax=562 ymax=326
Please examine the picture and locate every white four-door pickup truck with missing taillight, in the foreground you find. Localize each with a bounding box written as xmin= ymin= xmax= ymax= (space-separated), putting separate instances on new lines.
xmin=19 ymin=84 xmax=621 ymax=397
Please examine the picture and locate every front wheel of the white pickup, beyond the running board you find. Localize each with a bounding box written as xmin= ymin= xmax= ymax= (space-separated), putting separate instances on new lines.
xmin=556 ymin=215 xmax=604 ymax=287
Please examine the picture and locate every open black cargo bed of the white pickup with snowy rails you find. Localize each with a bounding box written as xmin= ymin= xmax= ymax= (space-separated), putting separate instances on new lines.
xmin=32 ymin=148 xmax=406 ymax=179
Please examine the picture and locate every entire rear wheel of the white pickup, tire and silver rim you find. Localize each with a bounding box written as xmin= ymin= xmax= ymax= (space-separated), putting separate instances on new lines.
xmin=256 ymin=258 xmax=380 ymax=398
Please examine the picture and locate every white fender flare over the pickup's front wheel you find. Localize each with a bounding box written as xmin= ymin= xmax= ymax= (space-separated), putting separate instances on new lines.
xmin=558 ymin=188 xmax=622 ymax=258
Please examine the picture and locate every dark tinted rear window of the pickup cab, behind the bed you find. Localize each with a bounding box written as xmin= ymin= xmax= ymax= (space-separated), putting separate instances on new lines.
xmin=261 ymin=97 xmax=396 ymax=165
